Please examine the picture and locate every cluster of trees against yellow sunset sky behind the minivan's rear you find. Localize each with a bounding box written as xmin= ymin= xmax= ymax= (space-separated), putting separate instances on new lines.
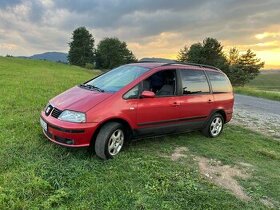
xmin=178 ymin=38 xmax=264 ymax=86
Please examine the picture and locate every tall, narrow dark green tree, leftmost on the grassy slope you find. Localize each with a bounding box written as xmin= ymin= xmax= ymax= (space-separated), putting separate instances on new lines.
xmin=68 ymin=27 xmax=94 ymax=67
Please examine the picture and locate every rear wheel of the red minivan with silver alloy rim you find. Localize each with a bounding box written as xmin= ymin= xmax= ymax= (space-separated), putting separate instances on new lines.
xmin=202 ymin=113 xmax=224 ymax=138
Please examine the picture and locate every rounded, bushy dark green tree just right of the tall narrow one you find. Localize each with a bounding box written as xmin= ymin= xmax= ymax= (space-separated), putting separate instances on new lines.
xmin=96 ymin=38 xmax=137 ymax=69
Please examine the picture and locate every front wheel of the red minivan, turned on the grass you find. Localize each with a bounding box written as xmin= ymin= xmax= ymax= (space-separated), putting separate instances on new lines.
xmin=95 ymin=122 xmax=125 ymax=160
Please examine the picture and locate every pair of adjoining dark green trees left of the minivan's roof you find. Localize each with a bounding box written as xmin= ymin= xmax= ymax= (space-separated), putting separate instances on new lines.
xmin=68 ymin=27 xmax=137 ymax=69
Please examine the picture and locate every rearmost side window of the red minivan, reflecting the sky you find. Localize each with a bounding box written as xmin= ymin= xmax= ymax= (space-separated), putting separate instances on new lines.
xmin=207 ymin=71 xmax=232 ymax=93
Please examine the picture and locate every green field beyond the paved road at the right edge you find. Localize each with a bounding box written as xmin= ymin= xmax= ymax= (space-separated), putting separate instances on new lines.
xmin=235 ymin=71 xmax=280 ymax=101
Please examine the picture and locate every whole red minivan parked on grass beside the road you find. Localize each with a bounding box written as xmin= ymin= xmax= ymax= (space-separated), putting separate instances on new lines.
xmin=40 ymin=62 xmax=234 ymax=159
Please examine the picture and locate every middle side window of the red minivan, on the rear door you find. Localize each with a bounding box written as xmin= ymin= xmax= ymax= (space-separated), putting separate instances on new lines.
xmin=180 ymin=70 xmax=210 ymax=95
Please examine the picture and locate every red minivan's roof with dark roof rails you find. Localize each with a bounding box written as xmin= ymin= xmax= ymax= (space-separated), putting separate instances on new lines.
xmin=129 ymin=62 xmax=221 ymax=72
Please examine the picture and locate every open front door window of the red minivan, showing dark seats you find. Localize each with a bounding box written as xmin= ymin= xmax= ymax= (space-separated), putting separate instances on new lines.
xmin=142 ymin=70 xmax=176 ymax=97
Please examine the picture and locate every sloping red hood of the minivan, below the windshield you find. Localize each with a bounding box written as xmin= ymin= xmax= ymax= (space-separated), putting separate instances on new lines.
xmin=50 ymin=86 xmax=112 ymax=112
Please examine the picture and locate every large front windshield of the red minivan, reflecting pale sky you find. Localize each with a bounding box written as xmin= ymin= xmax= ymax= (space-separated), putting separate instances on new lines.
xmin=84 ymin=65 xmax=149 ymax=92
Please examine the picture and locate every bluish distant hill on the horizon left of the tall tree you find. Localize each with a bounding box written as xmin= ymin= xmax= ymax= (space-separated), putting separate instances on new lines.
xmin=19 ymin=52 xmax=68 ymax=63
